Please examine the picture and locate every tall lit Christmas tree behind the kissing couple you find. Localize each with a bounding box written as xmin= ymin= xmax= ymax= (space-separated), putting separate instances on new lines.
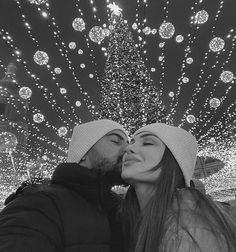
xmin=99 ymin=5 xmax=166 ymax=134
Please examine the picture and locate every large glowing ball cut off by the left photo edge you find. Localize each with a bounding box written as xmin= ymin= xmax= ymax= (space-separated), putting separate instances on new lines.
xmin=0 ymin=131 xmax=18 ymax=152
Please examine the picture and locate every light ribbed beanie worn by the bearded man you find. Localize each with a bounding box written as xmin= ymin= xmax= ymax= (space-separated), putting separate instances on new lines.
xmin=67 ymin=119 xmax=127 ymax=163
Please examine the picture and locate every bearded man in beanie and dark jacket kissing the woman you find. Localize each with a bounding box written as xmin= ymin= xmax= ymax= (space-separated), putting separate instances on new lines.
xmin=0 ymin=120 xmax=128 ymax=252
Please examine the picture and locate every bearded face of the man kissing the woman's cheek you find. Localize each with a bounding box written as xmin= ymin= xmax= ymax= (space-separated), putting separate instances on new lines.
xmin=86 ymin=130 xmax=128 ymax=172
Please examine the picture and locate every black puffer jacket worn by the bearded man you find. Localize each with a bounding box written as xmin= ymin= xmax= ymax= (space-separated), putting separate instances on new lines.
xmin=0 ymin=163 xmax=123 ymax=252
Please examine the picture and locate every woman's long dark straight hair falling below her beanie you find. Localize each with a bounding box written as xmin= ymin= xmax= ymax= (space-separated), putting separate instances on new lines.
xmin=122 ymin=147 xmax=236 ymax=252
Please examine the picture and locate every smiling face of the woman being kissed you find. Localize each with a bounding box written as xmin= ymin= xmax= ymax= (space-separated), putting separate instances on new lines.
xmin=121 ymin=131 xmax=166 ymax=184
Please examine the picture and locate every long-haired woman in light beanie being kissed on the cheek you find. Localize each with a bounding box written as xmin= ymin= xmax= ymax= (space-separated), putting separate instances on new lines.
xmin=122 ymin=123 xmax=236 ymax=252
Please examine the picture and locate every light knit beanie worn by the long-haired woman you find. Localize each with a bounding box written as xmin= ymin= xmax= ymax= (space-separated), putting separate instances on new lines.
xmin=134 ymin=123 xmax=198 ymax=186
